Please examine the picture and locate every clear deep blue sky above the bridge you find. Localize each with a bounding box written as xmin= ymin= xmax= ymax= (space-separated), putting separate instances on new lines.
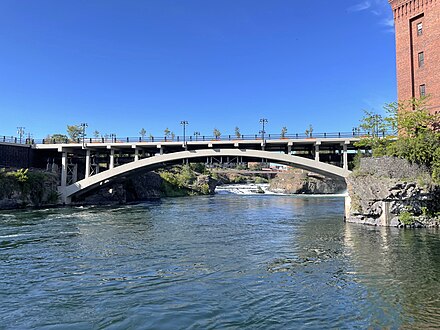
xmin=0 ymin=0 xmax=396 ymax=138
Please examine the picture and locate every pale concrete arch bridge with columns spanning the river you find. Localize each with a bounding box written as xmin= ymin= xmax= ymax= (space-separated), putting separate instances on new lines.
xmin=28 ymin=134 xmax=372 ymax=203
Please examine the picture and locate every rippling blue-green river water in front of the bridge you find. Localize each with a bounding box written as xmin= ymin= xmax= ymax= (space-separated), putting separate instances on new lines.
xmin=0 ymin=194 xmax=440 ymax=329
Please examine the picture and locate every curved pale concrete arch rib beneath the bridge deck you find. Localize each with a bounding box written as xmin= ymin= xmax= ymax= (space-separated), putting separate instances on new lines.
xmin=60 ymin=149 xmax=350 ymax=202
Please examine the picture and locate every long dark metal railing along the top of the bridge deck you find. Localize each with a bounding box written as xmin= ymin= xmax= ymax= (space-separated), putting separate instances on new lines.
xmin=9 ymin=131 xmax=396 ymax=144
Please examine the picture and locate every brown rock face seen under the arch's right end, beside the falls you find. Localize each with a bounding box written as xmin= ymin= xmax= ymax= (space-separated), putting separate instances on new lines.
xmin=269 ymin=169 xmax=346 ymax=194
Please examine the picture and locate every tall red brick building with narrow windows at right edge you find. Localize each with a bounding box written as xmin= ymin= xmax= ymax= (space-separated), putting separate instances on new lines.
xmin=389 ymin=0 xmax=440 ymax=112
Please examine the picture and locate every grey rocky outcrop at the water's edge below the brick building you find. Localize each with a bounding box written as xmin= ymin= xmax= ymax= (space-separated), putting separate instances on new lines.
xmin=346 ymin=157 xmax=440 ymax=227
